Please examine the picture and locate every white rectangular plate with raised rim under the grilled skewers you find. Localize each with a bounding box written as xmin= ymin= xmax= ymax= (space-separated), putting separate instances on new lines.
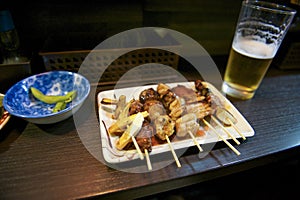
xmin=97 ymin=82 xmax=254 ymax=163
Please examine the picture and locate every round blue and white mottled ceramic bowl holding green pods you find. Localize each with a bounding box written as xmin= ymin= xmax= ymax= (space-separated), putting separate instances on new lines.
xmin=3 ymin=71 xmax=90 ymax=124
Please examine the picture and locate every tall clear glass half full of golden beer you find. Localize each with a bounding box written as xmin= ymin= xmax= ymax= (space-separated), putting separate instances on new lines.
xmin=222 ymin=1 xmax=296 ymax=99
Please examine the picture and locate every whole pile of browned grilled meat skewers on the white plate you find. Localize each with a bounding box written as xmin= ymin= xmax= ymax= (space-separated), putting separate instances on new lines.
xmin=103 ymin=80 xmax=244 ymax=167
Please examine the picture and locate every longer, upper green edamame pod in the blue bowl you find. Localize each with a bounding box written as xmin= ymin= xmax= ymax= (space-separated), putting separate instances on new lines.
xmin=30 ymin=87 xmax=76 ymax=104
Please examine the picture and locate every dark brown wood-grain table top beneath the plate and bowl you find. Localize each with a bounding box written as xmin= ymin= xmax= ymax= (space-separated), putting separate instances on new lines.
xmin=0 ymin=66 xmax=300 ymax=199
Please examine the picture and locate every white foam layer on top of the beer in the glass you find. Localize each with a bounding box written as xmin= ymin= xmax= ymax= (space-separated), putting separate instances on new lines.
xmin=232 ymin=39 xmax=276 ymax=59
